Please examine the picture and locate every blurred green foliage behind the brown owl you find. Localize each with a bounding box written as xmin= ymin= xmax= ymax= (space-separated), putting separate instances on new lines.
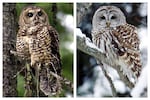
xmin=16 ymin=3 xmax=73 ymax=96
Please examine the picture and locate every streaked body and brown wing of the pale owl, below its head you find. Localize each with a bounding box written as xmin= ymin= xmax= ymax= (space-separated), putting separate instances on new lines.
xmin=92 ymin=24 xmax=141 ymax=81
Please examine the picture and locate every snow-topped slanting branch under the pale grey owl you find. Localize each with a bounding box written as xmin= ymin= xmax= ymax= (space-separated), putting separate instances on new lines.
xmin=76 ymin=29 xmax=134 ymax=89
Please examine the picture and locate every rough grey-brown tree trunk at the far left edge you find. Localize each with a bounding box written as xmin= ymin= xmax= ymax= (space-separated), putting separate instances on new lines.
xmin=3 ymin=3 xmax=17 ymax=97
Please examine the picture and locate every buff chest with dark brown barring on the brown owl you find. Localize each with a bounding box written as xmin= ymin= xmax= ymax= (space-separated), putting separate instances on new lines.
xmin=16 ymin=26 xmax=51 ymax=65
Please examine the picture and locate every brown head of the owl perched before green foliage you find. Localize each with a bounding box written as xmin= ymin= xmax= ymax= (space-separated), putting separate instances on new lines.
xmin=19 ymin=6 xmax=49 ymax=26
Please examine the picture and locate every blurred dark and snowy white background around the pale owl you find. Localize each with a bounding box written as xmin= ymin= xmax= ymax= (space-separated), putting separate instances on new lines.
xmin=77 ymin=3 xmax=148 ymax=97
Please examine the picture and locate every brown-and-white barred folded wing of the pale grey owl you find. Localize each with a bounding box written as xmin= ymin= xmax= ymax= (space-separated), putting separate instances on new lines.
xmin=112 ymin=24 xmax=142 ymax=77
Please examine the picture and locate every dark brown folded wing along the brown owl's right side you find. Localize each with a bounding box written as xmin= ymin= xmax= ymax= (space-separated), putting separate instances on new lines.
xmin=48 ymin=26 xmax=61 ymax=75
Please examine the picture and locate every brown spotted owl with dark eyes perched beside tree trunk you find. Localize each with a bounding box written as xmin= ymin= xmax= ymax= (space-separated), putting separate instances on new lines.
xmin=16 ymin=6 xmax=61 ymax=96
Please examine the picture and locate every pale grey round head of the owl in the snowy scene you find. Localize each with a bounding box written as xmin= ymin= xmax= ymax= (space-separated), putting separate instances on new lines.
xmin=92 ymin=6 xmax=126 ymax=30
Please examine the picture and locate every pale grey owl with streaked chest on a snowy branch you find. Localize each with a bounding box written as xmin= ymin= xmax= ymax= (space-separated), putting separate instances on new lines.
xmin=92 ymin=6 xmax=142 ymax=83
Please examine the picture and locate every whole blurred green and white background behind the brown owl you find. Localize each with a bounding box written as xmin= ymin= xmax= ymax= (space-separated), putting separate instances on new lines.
xmin=3 ymin=3 xmax=74 ymax=96
